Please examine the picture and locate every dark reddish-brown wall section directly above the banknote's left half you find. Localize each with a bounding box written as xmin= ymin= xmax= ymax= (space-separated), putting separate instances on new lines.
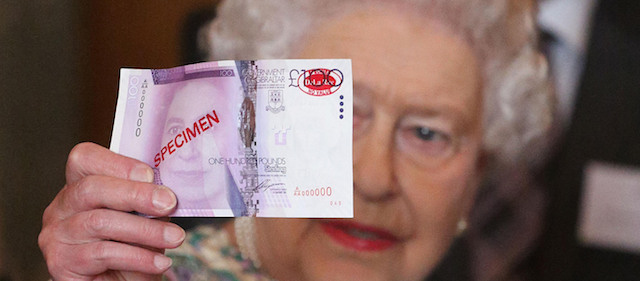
xmin=82 ymin=0 xmax=217 ymax=146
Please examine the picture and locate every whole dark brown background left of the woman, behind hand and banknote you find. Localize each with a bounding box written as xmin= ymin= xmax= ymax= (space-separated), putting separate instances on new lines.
xmin=0 ymin=0 xmax=217 ymax=281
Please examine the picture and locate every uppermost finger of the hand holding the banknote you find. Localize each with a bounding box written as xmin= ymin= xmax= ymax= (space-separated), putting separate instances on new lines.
xmin=66 ymin=142 xmax=153 ymax=184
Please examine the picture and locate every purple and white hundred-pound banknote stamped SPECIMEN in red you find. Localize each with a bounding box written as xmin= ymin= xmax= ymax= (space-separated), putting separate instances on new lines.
xmin=111 ymin=59 xmax=353 ymax=218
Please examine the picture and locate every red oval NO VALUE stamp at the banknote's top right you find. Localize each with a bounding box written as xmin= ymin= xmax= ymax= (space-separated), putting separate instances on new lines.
xmin=298 ymin=68 xmax=343 ymax=96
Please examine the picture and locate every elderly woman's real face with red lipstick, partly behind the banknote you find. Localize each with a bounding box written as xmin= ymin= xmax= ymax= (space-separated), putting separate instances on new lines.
xmin=256 ymin=7 xmax=482 ymax=280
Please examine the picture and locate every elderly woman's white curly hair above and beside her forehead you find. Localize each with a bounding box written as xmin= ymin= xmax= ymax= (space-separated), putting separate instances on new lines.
xmin=203 ymin=0 xmax=554 ymax=172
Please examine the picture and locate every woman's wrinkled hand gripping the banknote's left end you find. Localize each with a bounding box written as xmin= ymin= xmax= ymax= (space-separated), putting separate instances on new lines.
xmin=38 ymin=143 xmax=185 ymax=281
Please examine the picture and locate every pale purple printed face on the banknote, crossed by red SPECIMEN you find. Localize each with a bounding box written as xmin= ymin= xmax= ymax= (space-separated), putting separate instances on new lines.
xmin=158 ymin=81 xmax=232 ymax=208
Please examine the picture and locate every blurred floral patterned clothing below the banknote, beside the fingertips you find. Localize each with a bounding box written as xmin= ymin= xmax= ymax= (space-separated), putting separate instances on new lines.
xmin=163 ymin=226 xmax=274 ymax=281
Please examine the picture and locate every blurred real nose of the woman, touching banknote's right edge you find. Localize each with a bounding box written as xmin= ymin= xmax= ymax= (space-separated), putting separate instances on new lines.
xmin=353 ymin=123 xmax=398 ymax=201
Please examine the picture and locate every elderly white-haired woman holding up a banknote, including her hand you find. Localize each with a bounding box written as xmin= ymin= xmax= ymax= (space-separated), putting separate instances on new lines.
xmin=39 ymin=0 xmax=551 ymax=280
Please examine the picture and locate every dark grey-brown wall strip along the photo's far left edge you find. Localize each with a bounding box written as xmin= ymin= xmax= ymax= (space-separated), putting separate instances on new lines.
xmin=0 ymin=0 xmax=82 ymax=281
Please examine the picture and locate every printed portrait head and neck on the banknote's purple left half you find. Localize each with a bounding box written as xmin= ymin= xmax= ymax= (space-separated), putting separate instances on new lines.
xmin=154 ymin=78 xmax=242 ymax=212
